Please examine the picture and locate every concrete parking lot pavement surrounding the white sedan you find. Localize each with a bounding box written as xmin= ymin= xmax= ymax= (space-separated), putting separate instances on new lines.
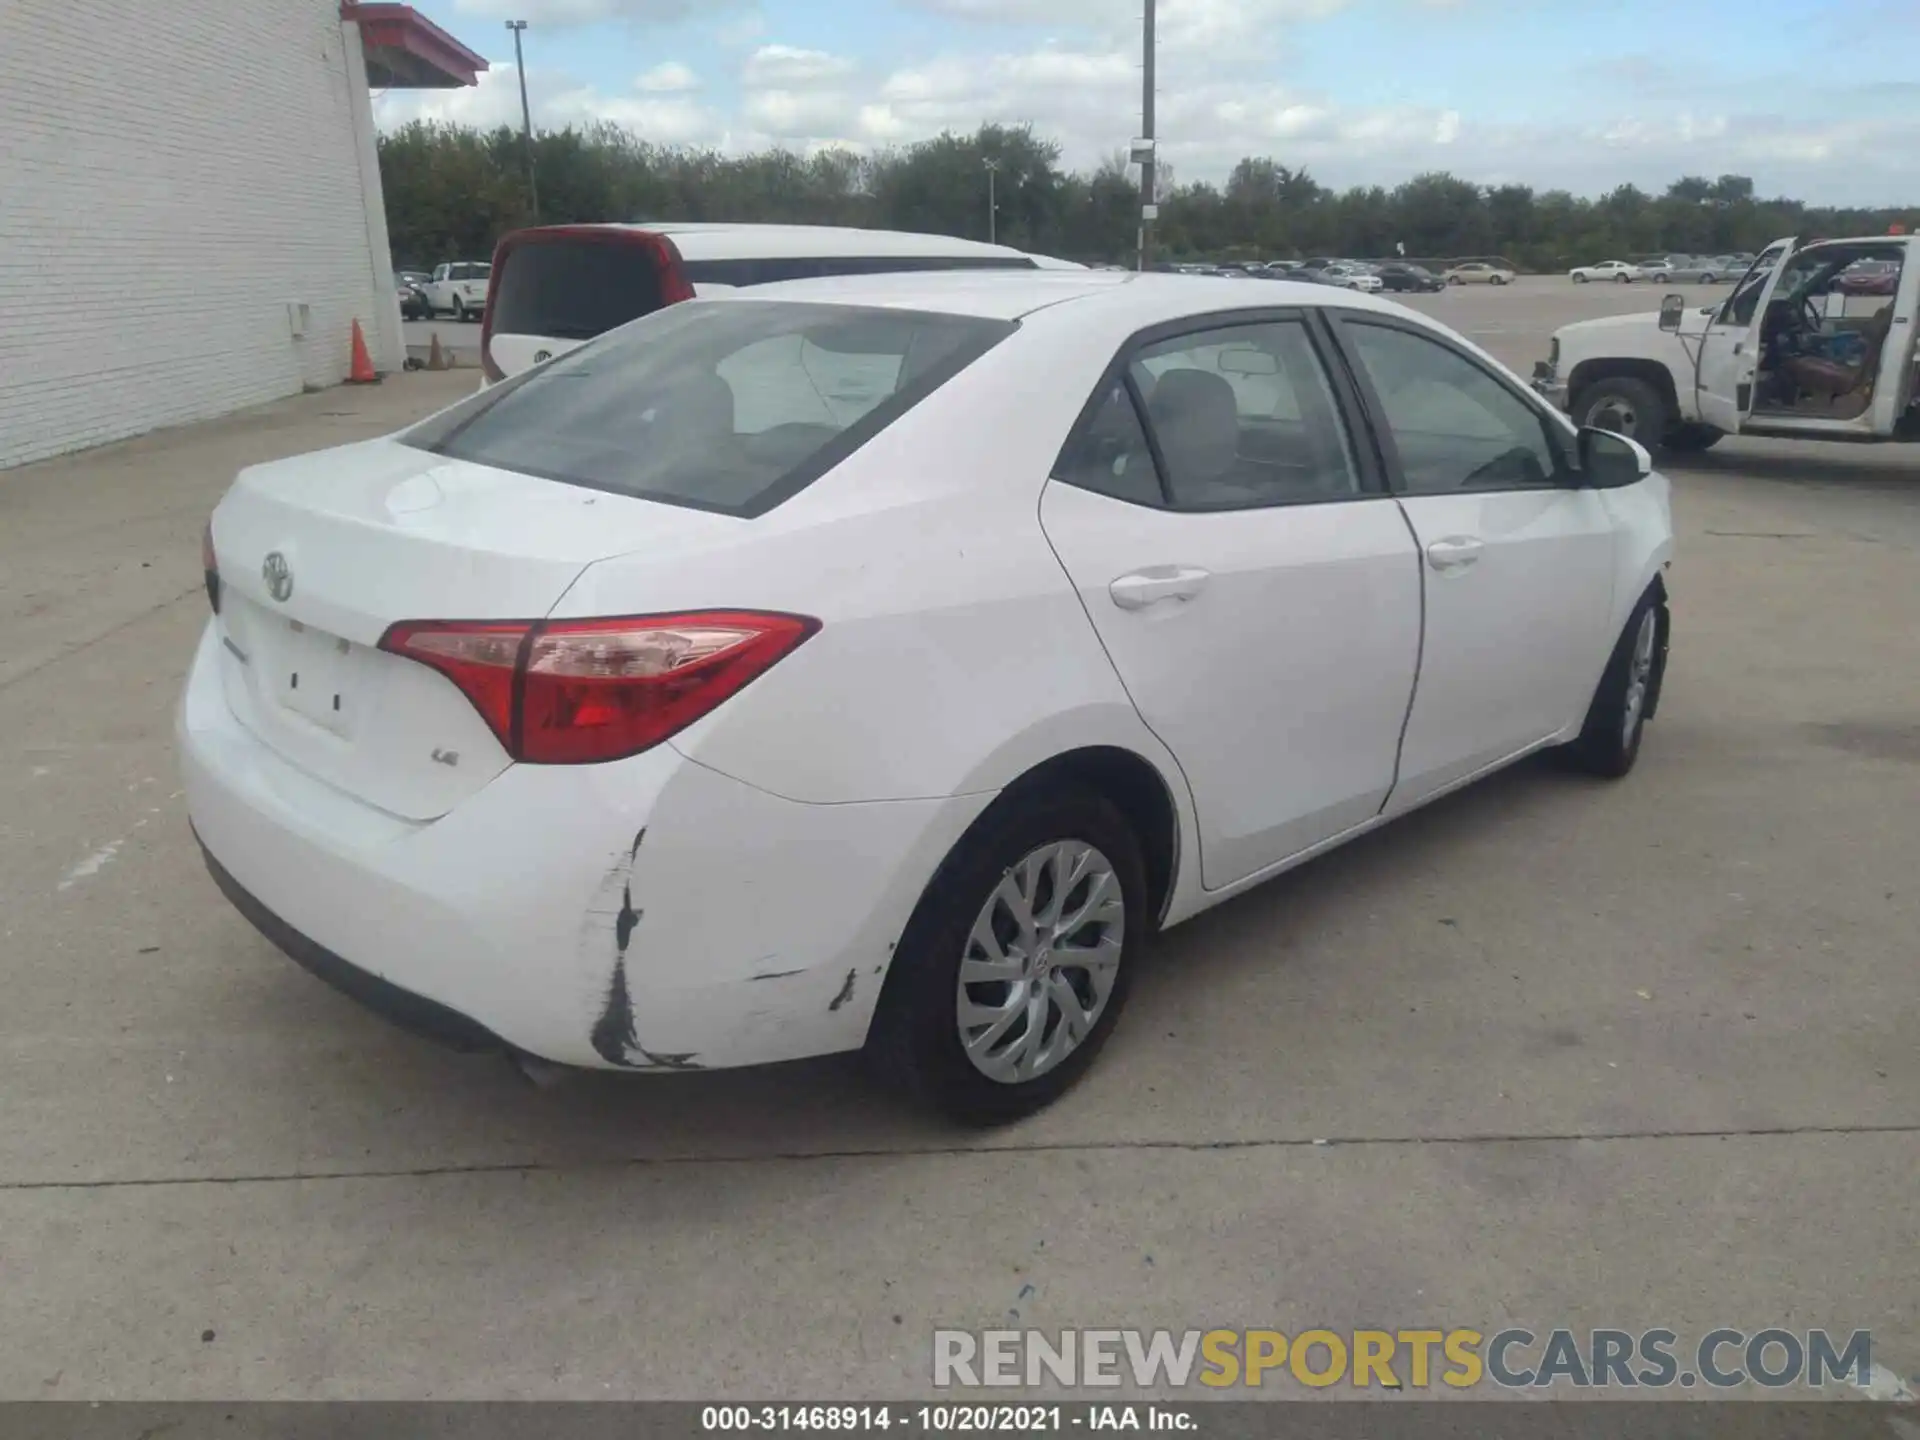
xmin=0 ymin=278 xmax=1920 ymax=1400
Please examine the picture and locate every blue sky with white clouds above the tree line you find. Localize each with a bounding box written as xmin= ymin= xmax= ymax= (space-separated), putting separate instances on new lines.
xmin=376 ymin=0 xmax=1920 ymax=209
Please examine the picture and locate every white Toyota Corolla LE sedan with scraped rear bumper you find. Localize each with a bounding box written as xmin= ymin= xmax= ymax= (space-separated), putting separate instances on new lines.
xmin=179 ymin=271 xmax=1672 ymax=1121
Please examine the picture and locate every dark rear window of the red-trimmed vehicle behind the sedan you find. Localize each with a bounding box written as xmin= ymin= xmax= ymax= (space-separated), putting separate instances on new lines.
xmin=492 ymin=240 xmax=660 ymax=340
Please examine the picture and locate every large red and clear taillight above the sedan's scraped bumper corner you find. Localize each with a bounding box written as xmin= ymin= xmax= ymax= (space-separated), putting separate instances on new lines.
xmin=380 ymin=611 xmax=820 ymax=764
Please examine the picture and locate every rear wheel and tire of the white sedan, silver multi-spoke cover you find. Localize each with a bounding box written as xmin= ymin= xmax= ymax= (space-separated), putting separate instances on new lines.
xmin=868 ymin=787 xmax=1150 ymax=1125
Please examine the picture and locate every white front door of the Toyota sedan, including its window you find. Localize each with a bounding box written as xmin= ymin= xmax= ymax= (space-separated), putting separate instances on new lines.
xmin=1338 ymin=311 xmax=1619 ymax=810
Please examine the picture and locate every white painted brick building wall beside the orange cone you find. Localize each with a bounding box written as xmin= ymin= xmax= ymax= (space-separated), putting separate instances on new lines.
xmin=0 ymin=0 xmax=403 ymax=468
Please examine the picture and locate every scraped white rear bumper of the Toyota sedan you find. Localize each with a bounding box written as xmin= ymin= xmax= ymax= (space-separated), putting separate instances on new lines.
xmin=179 ymin=626 xmax=991 ymax=1069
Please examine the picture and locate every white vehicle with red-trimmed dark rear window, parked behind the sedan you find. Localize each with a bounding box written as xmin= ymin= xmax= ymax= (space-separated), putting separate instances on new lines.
xmin=480 ymin=221 xmax=1052 ymax=384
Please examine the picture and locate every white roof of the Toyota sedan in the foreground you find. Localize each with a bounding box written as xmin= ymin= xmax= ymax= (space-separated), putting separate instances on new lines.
xmin=698 ymin=271 xmax=1415 ymax=326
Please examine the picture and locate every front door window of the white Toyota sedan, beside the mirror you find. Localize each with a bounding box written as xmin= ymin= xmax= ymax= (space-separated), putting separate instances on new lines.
xmin=1346 ymin=321 xmax=1567 ymax=495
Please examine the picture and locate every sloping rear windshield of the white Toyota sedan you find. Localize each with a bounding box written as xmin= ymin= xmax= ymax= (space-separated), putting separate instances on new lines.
xmin=403 ymin=299 xmax=1016 ymax=516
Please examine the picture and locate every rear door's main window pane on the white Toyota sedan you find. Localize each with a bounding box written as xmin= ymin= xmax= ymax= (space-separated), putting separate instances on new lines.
xmin=1129 ymin=321 xmax=1359 ymax=511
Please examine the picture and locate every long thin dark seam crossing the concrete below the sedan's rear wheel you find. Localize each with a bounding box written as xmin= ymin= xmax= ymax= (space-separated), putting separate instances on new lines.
xmin=0 ymin=1123 xmax=1920 ymax=1194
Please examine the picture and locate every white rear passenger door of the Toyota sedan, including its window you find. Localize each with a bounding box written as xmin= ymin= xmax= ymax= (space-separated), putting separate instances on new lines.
xmin=1041 ymin=311 xmax=1421 ymax=889
